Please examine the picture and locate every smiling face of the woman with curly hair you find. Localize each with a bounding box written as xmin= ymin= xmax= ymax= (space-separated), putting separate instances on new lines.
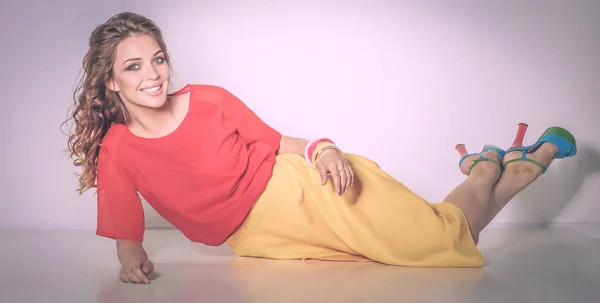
xmin=107 ymin=35 xmax=169 ymax=109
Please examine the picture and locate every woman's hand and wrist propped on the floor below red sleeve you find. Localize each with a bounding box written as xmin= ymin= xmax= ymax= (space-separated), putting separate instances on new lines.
xmin=117 ymin=240 xmax=154 ymax=284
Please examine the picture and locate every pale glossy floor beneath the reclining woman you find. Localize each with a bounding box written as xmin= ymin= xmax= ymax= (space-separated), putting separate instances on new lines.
xmin=0 ymin=228 xmax=600 ymax=303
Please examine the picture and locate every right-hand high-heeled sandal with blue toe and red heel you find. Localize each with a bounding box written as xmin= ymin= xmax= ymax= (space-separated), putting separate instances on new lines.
xmin=504 ymin=123 xmax=577 ymax=174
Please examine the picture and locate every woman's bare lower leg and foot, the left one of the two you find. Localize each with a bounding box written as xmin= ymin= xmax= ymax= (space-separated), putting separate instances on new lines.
xmin=444 ymin=151 xmax=500 ymax=243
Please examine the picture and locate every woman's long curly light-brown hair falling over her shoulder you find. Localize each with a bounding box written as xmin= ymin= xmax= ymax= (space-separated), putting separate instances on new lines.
xmin=63 ymin=12 xmax=171 ymax=195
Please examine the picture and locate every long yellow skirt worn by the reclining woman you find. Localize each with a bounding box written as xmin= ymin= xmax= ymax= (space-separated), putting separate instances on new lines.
xmin=227 ymin=153 xmax=483 ymax=267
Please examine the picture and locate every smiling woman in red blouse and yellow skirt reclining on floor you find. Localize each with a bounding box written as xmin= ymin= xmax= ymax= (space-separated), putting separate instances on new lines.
xmin=68 ymin=13 xmax=576 ymax=283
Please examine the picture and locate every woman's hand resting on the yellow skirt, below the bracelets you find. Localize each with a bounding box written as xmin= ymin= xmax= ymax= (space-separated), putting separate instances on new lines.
xmin=315 ymin=149 xmax=354 ymax=195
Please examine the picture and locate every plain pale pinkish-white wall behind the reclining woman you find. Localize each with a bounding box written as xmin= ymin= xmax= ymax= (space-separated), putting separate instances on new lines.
xmin=0 ymin=0 xmax=600 ymax=228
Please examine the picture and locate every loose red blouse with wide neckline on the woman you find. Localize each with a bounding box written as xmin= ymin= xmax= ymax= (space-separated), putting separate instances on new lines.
xmin=96 ymin=85 xmax=281 ymax=245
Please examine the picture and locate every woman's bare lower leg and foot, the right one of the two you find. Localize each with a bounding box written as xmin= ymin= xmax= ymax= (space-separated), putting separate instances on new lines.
xmin=482 ymin=143 xmax=558 ymax=228
